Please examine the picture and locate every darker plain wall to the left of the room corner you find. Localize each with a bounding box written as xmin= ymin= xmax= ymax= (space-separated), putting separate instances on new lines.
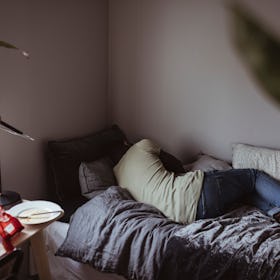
xmin=0 ymin=0 xmax=108 ymax=199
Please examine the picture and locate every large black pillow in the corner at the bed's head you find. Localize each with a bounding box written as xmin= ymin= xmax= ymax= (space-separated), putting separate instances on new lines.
xmin=48 ymin=125 xmax=128 ymax=203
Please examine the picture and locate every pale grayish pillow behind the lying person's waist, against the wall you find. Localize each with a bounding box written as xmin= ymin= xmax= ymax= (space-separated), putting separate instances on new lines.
xmin=184 ymin=155 xmax=232 ymax=172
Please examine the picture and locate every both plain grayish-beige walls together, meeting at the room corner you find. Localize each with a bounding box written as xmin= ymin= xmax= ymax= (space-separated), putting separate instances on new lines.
xmin=0 ymin=0 xmax=280 ymax=199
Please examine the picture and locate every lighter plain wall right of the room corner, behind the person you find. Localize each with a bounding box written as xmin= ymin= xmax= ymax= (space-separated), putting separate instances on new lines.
xmin=109 ymin=0 xmax=280 ymax=160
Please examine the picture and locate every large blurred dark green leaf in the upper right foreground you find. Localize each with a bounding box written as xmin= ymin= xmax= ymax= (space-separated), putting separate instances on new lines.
xmin=231 ymin=4 xmax=280 ymax=105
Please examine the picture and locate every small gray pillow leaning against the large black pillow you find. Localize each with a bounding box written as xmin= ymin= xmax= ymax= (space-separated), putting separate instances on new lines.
xmin=79 ymin=158 xmax=116 ymax=199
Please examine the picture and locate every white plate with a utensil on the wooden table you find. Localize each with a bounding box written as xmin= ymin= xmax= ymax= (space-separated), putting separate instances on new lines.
xmin=7 ymin=200 xmax=64 ymax=225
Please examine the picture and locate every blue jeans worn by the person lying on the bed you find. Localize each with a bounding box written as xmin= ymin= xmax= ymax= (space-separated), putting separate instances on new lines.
xmin=196 ymin=169 xmax=280 ymax=219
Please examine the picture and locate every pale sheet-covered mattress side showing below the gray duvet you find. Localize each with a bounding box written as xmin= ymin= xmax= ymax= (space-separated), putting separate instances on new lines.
xmin=44 ymin=222 xmax=125 ymax=280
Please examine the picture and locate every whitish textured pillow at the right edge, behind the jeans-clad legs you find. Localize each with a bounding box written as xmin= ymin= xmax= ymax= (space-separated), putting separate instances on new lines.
xmin=232 ymin=144 xmax=280 ymax=180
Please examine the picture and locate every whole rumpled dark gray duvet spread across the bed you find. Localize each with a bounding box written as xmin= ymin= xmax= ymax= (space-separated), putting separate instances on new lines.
xmin=57 ymin=187 xmax=280 ymax=280
